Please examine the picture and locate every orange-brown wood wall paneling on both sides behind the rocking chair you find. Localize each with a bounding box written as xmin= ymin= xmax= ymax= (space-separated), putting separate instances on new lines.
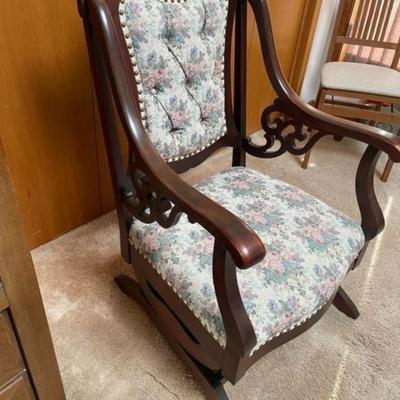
xmin=0 ymin=0 xmax=320 ymax=248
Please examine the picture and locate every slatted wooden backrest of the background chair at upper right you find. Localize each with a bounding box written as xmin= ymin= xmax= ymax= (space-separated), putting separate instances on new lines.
xmin=328 ymin=0 xmax=400 ymax=68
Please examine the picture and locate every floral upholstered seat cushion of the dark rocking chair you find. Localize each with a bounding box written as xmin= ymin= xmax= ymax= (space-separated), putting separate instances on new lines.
xmin=131 ymin=167 xmax=364 ymax=351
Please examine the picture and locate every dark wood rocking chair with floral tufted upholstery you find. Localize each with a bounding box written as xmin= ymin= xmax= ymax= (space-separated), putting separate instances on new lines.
xmin=78 ymin=0 xmax=400 ymax=400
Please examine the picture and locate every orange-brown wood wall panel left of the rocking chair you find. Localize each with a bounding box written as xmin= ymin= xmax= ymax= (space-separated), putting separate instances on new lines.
xmin=0 ymin=0 xmax=100 ymax=247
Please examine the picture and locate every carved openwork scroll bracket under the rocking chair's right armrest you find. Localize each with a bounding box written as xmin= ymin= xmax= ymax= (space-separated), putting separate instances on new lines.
xmin=243 ymin=99 xmax=331 ymax=158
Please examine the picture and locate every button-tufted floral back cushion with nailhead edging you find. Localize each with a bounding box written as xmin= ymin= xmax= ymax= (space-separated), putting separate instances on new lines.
xmin=119 ymin=0 xmax=228 ymax=161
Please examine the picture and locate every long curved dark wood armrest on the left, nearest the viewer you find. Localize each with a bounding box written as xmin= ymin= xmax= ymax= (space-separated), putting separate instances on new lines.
xmin=89 ymin=0 xmax=265 ymax=269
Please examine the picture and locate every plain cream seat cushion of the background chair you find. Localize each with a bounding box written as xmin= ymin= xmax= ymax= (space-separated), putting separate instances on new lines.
xmin=322 ymin=62 xmax=400 ymax=97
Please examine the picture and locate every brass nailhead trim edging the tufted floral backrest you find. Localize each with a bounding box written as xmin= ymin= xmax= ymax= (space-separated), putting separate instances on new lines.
xmin=119 ymin=0 xmax=229 ymax=162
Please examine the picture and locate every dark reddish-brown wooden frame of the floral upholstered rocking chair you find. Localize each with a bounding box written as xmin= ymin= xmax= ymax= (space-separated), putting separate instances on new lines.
xmin=78 ymin=0 xmax=400 ymax=400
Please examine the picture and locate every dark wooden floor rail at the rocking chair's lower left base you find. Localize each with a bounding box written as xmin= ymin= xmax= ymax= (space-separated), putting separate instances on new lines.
xmin=115 ymin=275 xmax=229 ymax=400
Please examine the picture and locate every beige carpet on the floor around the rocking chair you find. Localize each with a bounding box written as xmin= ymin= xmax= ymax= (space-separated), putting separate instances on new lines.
xmin=33 ymin=138 xmax=400 ymax=400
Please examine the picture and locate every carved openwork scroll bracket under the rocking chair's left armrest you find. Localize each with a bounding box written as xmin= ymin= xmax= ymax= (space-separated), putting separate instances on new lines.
xmin=123 ymin=166 xmax=182 ymax=228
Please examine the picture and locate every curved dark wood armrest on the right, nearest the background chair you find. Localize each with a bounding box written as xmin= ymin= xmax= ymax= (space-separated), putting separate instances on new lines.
xmin=249 ymin=0 xmax=400 ymax=162
